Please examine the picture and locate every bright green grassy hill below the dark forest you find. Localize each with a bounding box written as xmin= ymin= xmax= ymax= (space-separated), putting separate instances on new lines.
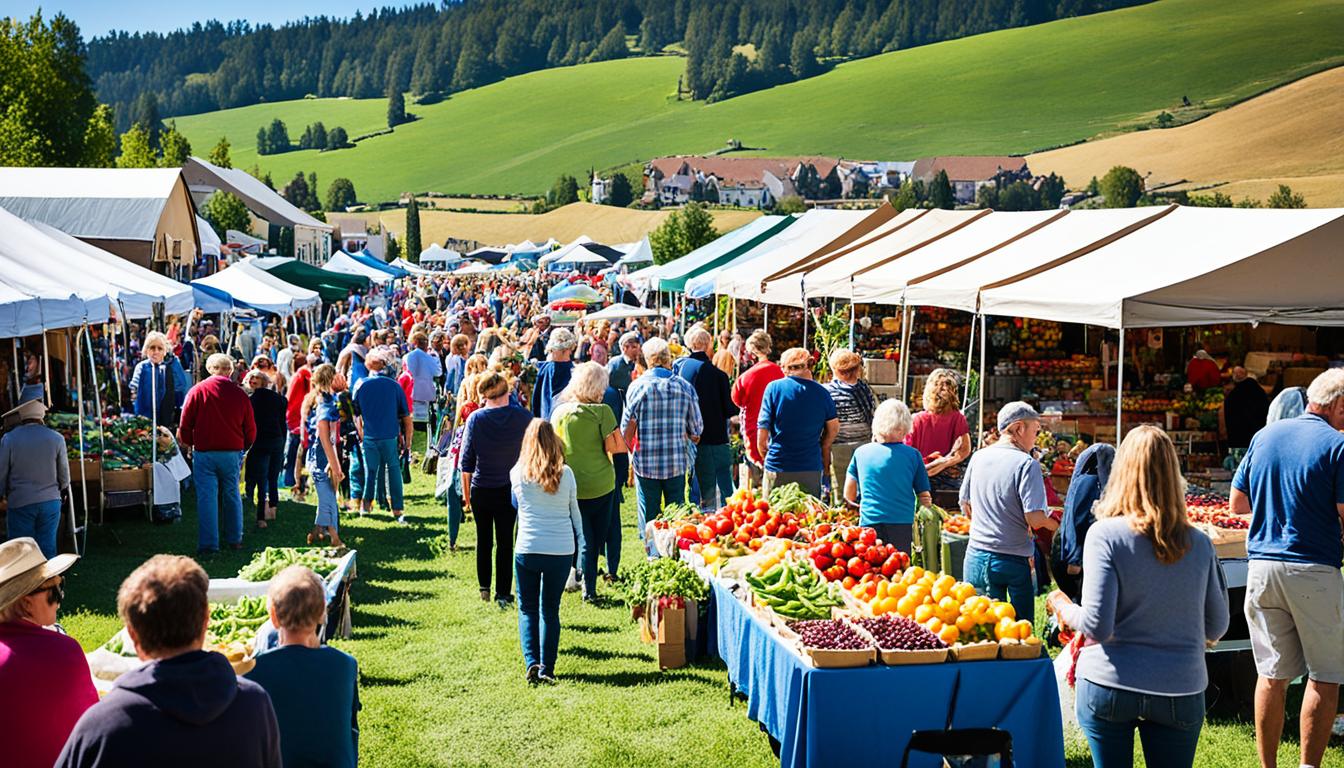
xmin=177 ymin=0 xmax=1344 ymax=200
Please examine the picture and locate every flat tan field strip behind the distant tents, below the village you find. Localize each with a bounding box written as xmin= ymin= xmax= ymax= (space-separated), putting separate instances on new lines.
xmin=366 ymin=203 xmax=761 ymax=247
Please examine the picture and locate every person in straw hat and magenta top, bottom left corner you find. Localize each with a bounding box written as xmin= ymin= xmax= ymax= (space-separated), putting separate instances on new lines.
xmin=0 ymin=537 xmax=98 ymax=768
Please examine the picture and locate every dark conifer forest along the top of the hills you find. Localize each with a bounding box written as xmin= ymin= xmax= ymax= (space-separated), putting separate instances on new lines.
xmin=87 ymin=0 xmax=1145 ymax=128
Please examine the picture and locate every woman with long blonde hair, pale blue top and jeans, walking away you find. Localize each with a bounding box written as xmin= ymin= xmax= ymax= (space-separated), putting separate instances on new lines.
xmin=509 ymin=418 xmax=583 ymax=685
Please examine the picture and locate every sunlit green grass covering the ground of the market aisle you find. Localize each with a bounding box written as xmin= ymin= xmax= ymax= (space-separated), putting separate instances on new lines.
xmin=60 ymin=435 xmax=1322 ymax=768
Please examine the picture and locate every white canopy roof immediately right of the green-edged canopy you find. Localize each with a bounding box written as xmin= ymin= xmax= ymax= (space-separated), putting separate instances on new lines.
xmin=704 ymin=210 xmax=871 ymax=304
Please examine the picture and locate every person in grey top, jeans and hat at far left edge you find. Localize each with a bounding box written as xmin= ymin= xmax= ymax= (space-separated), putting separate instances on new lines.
xmin=0 ymin=399 xmax=70 ymax=558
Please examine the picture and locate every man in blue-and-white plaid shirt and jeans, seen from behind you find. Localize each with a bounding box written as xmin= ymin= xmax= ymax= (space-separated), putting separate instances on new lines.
xmin=621 ymin=338 xmax=704 ymax=554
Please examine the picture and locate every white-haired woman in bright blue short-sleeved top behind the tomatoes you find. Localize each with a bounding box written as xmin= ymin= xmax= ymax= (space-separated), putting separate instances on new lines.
xmin=844 ymin=398 xmax=933 ymax=551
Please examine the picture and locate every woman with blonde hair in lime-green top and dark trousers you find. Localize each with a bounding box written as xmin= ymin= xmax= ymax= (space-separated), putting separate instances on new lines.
xmin=551 ymin=362 xmax=626 ymax=603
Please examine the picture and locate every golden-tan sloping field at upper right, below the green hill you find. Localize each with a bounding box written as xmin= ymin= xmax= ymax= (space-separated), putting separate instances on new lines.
xmin=1031 ymin=67 xmax=1344 ymax=206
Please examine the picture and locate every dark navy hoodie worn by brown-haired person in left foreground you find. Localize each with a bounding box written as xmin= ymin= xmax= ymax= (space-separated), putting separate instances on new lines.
xmin=56 ymin=651 xmax=281 ymax=768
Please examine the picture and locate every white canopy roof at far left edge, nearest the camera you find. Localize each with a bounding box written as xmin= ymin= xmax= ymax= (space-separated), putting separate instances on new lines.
xmin=0 ymin=208 xmax=116 ymax=339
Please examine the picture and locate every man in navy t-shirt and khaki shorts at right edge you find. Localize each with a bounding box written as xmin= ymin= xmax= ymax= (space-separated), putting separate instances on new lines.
xmin=1231 ymin=369 xmax=1344 ymax=765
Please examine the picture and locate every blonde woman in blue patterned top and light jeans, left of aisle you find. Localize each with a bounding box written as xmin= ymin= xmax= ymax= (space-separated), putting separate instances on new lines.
xmin=301 ymin=363 xmax=345 ymax=547
